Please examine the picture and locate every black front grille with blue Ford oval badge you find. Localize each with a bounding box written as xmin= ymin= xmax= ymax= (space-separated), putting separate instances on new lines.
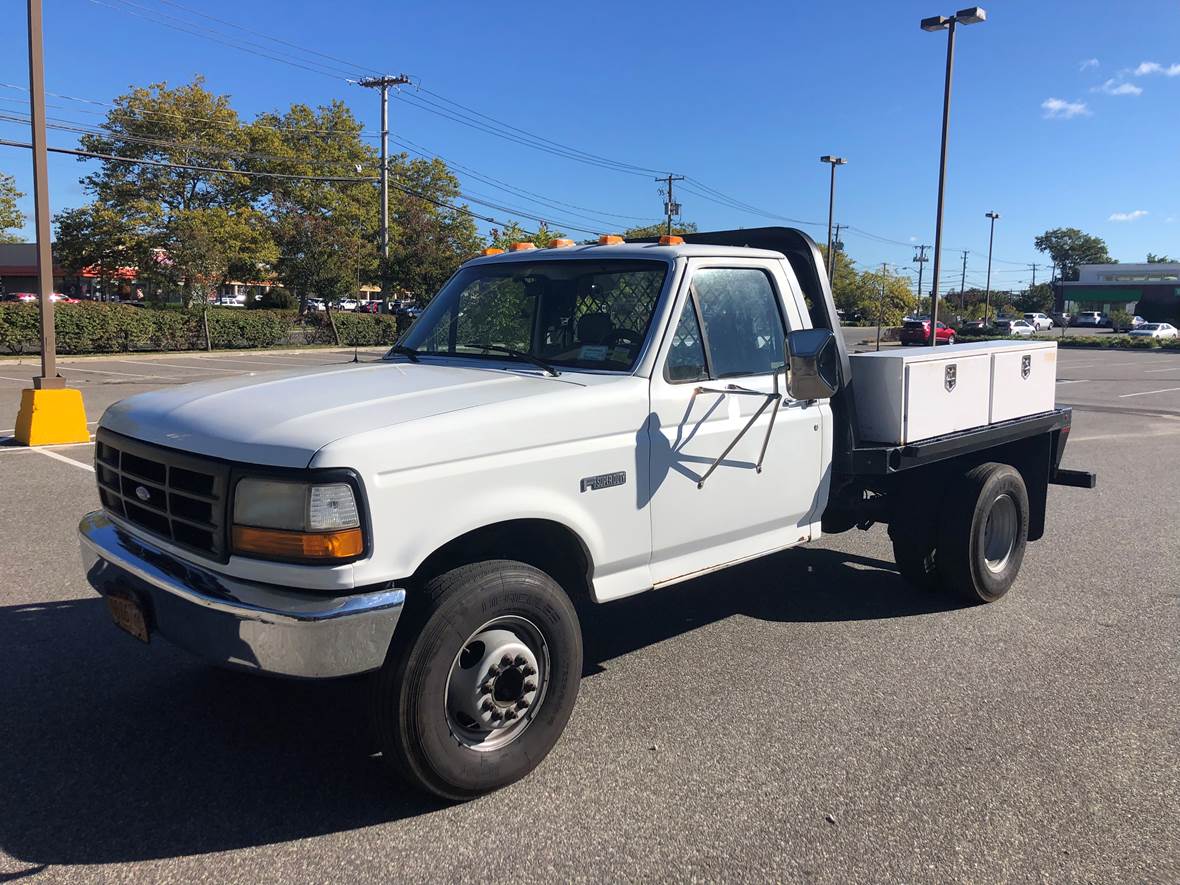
xmin=94 ymin=430 xmax=229 ymax=561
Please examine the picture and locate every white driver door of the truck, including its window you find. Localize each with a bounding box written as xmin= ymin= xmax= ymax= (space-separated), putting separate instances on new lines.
xmin=648 ymin=260 xmax=826 ymax=584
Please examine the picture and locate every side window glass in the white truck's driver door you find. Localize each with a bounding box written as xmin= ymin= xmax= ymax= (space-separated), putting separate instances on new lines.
xmin=666 ymin=268 xmax=786 ymax=381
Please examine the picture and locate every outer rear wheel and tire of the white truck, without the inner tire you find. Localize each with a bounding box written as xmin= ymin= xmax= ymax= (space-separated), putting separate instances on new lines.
xmin=937 ymin=463 xmax=1029 ymax=603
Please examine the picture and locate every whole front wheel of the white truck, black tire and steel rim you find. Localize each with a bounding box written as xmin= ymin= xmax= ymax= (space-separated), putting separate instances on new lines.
xmin=372 ymin=559 xmax=582 ymax=801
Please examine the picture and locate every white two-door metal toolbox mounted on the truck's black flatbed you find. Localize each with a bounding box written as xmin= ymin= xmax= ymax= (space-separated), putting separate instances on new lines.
xmin=850 ymin=341 xmax=1057 ymax=445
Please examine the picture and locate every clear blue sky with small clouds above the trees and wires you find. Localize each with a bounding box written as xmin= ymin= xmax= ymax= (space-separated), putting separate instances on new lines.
xmin=0 ymin=0 xmax=1180 ymax=288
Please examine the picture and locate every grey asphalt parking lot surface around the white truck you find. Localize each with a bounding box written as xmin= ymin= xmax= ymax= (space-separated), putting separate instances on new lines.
xmin=0 ymin=349 xmax=1180 ymax=883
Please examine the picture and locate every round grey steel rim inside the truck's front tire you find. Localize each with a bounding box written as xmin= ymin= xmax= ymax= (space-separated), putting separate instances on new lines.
xmin=443 ymin=615 xmax=550 ymax=752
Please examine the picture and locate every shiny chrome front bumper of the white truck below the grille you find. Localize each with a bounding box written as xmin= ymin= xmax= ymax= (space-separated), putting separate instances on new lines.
xmin=78 ymin=511 xmax=406 ymax=679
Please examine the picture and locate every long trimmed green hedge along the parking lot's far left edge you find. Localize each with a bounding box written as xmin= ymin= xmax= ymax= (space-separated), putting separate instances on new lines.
xmin=0 ymin=302 xmax=399 ymax=354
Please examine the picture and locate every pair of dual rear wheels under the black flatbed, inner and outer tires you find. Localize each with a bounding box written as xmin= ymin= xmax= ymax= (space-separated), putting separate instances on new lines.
xmin=890 ymin=463 xmax=1029 ymax=603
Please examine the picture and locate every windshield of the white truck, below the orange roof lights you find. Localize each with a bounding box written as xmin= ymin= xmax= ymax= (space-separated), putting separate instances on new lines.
xmin=399 ymin=260 xmax=668 ymax=372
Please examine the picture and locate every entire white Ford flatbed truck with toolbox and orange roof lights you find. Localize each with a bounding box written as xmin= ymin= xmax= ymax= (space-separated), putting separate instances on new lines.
xmin=79 ymin=228 xmax=1094 ymax=799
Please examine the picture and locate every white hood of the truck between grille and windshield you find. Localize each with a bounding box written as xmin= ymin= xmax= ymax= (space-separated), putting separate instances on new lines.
xmin=99 ymin=361 xmax=577 ymax=467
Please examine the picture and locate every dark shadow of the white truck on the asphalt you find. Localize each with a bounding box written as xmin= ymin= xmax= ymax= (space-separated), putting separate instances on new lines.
xmin=0 ymin=550 xmax=953 ymax=872
